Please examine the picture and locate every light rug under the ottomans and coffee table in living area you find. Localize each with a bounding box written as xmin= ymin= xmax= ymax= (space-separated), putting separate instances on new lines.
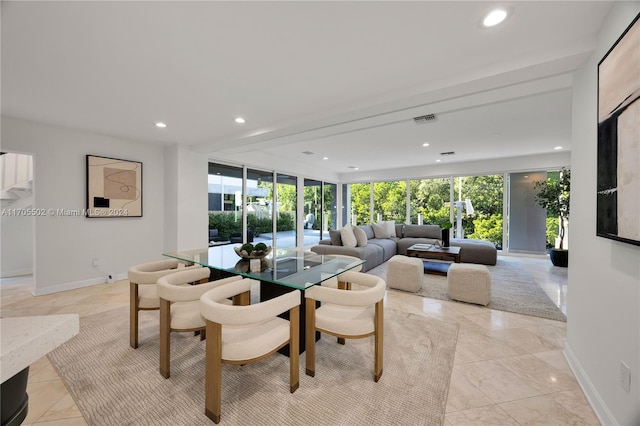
xmin=367 ymin=256 xmax=567 ymax=322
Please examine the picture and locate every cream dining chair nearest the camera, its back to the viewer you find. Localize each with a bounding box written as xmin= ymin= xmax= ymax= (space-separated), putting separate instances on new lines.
xmin=200 ymin=279 xmax=301 ymax=423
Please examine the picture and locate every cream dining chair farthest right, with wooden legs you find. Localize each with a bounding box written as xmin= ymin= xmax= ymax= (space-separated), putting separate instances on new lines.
xmin=305 ymin=271 xmax=386 ymax=382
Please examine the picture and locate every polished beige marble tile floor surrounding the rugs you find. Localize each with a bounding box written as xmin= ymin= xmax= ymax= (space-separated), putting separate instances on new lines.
xmin=0 ymin=258 xmax=599 ymax=426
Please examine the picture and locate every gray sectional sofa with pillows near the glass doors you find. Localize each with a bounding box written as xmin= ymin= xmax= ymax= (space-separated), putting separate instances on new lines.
xmin=311 ymin=224 xmax=498 ymax=271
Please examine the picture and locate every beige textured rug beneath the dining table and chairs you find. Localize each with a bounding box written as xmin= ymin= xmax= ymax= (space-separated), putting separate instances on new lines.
xmin=48 ymin=309 xmax=458 ymax=426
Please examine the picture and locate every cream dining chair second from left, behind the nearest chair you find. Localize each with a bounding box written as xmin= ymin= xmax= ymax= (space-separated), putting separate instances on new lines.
xmin=158 ymin=268 xmax=244 ymax=379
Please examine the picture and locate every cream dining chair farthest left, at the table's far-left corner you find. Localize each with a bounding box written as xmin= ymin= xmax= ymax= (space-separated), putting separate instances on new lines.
xmin=128 ymin=259 xmax=202 ymax=349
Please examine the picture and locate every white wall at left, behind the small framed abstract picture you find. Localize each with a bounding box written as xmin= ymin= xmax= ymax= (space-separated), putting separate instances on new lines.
xmin=2 ymin=116 xmax=168 ymax=295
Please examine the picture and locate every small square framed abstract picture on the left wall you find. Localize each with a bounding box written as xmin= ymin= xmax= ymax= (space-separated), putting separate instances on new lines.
xmin=86 ymin=155 xmax=142 ymax=217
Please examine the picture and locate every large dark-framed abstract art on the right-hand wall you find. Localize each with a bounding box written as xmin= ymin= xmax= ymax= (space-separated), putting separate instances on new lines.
xmin=596 ymin=14 xmax=640 ymax=245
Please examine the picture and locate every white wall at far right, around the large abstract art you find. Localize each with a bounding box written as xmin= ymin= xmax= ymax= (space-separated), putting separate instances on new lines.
xmin=565 ymin=1 xmax=640 ymax=425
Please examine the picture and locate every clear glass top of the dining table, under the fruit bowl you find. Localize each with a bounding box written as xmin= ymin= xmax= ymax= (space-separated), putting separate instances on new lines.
xmin=163 ymin=244 xmax=366 ymax=290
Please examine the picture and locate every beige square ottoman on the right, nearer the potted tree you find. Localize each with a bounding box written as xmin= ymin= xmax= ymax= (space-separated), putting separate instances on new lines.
xmin=447 ymin=263 xmax=491 ymax=306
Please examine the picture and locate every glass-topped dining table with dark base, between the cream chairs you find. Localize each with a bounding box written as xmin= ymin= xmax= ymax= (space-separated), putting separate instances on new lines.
xmin=163 ymin=244 xmax=365 ymax=355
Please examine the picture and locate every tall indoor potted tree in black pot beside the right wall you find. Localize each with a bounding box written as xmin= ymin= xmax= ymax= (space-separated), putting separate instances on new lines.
xmin=534 ymin=168 xmax=571 ymax=268
